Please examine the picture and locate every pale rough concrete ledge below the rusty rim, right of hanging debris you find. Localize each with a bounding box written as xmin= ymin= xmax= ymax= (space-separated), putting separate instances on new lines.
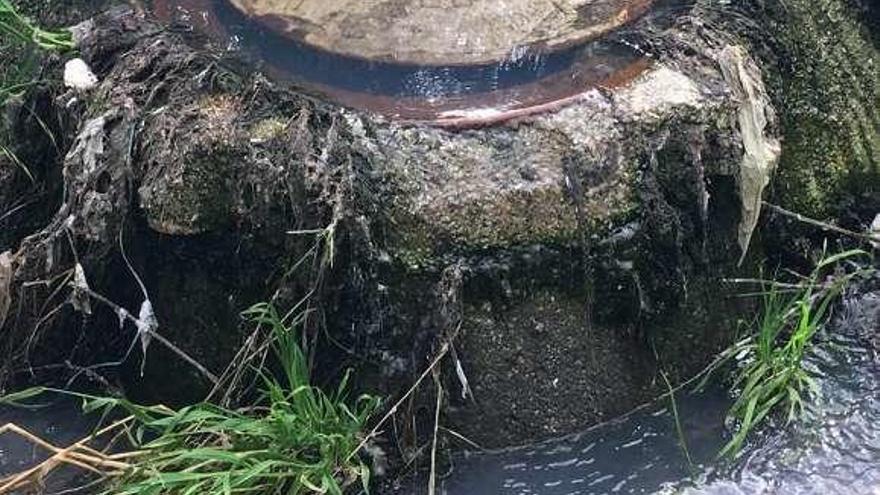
xmin=376 ymin=62 xmax=739 ymax=267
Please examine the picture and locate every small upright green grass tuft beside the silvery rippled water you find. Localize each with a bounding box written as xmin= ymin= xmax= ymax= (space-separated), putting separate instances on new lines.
xmin=719 ymin=250 xmax=868 ymax=457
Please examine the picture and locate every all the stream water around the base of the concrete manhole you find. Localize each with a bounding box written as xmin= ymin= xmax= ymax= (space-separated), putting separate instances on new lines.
xmin=0 ymin=290 xmax=880 ymax=495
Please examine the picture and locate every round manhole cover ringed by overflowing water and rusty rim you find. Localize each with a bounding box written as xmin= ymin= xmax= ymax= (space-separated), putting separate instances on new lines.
xmin=152 ymin=0 xmax=687 ymax=125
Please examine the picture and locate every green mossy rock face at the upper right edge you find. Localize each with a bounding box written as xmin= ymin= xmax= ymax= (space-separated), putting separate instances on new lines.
xmin=767 ymin=0 xmax=880 ymax=217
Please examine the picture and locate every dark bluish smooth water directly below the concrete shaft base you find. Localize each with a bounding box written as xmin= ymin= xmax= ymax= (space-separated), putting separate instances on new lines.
xmin=442 ymin=391 xmax=728 ymax=495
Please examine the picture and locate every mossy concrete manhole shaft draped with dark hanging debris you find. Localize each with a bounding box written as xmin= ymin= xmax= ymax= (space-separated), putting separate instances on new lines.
xmin=1 ymin=5 xmax=754 ymax=445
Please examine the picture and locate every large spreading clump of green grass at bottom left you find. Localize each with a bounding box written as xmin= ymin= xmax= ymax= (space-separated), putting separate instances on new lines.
xmin=0 ymin=304 xmax=379 ymax=495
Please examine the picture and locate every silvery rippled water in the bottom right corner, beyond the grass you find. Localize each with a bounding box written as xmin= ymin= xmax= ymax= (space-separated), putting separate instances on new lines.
xmin=687 ymin=288 xmax=880 ymax=495
